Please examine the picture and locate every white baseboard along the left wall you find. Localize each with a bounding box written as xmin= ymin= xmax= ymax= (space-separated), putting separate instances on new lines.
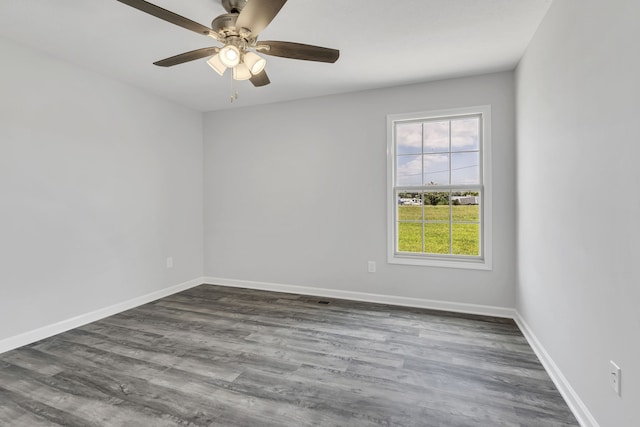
xmin=0 ymin=277 xmax=204 ymax=354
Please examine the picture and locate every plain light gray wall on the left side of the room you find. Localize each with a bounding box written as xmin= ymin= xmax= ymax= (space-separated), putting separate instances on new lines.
xmin=0 ymin=39 xmax=202 ymax=341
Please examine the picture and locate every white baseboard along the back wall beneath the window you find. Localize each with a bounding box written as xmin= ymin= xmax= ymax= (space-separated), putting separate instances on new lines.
xmin=203 ymin=277 xmax=515 ymax=319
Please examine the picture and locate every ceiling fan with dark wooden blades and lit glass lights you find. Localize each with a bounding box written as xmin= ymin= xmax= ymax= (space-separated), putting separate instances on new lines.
xmin=118 ymin=0 xmax=340 ymax=86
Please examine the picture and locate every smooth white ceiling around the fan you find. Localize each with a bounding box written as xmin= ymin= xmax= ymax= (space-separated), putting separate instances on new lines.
xmin=0 ymin=0 xmax=551 ymax=111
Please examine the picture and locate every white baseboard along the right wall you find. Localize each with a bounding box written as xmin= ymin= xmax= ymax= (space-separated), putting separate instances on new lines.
xmin=513 ymin=310 xmax=600 ymax=427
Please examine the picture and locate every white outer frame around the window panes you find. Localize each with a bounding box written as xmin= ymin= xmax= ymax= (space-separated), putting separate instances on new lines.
xmin=387 ymin=105 xmax=493 ymax=270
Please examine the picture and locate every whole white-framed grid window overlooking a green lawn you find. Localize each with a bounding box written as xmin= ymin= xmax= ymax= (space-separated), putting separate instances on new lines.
xmin=387 ymin=106 xmax=491 ymax=270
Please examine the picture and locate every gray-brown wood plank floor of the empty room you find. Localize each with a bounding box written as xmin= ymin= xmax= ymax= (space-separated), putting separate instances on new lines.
xmin=0 ymin=285 xmax=578 ymax=427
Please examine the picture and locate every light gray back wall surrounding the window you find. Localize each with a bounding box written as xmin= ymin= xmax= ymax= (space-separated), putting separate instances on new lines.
xmin=204 ymin=72 xmax=515 ymax=307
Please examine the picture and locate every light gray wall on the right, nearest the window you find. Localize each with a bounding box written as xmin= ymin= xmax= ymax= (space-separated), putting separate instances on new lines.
xmin=517 ymin=0 xmax=640 ymax=427
